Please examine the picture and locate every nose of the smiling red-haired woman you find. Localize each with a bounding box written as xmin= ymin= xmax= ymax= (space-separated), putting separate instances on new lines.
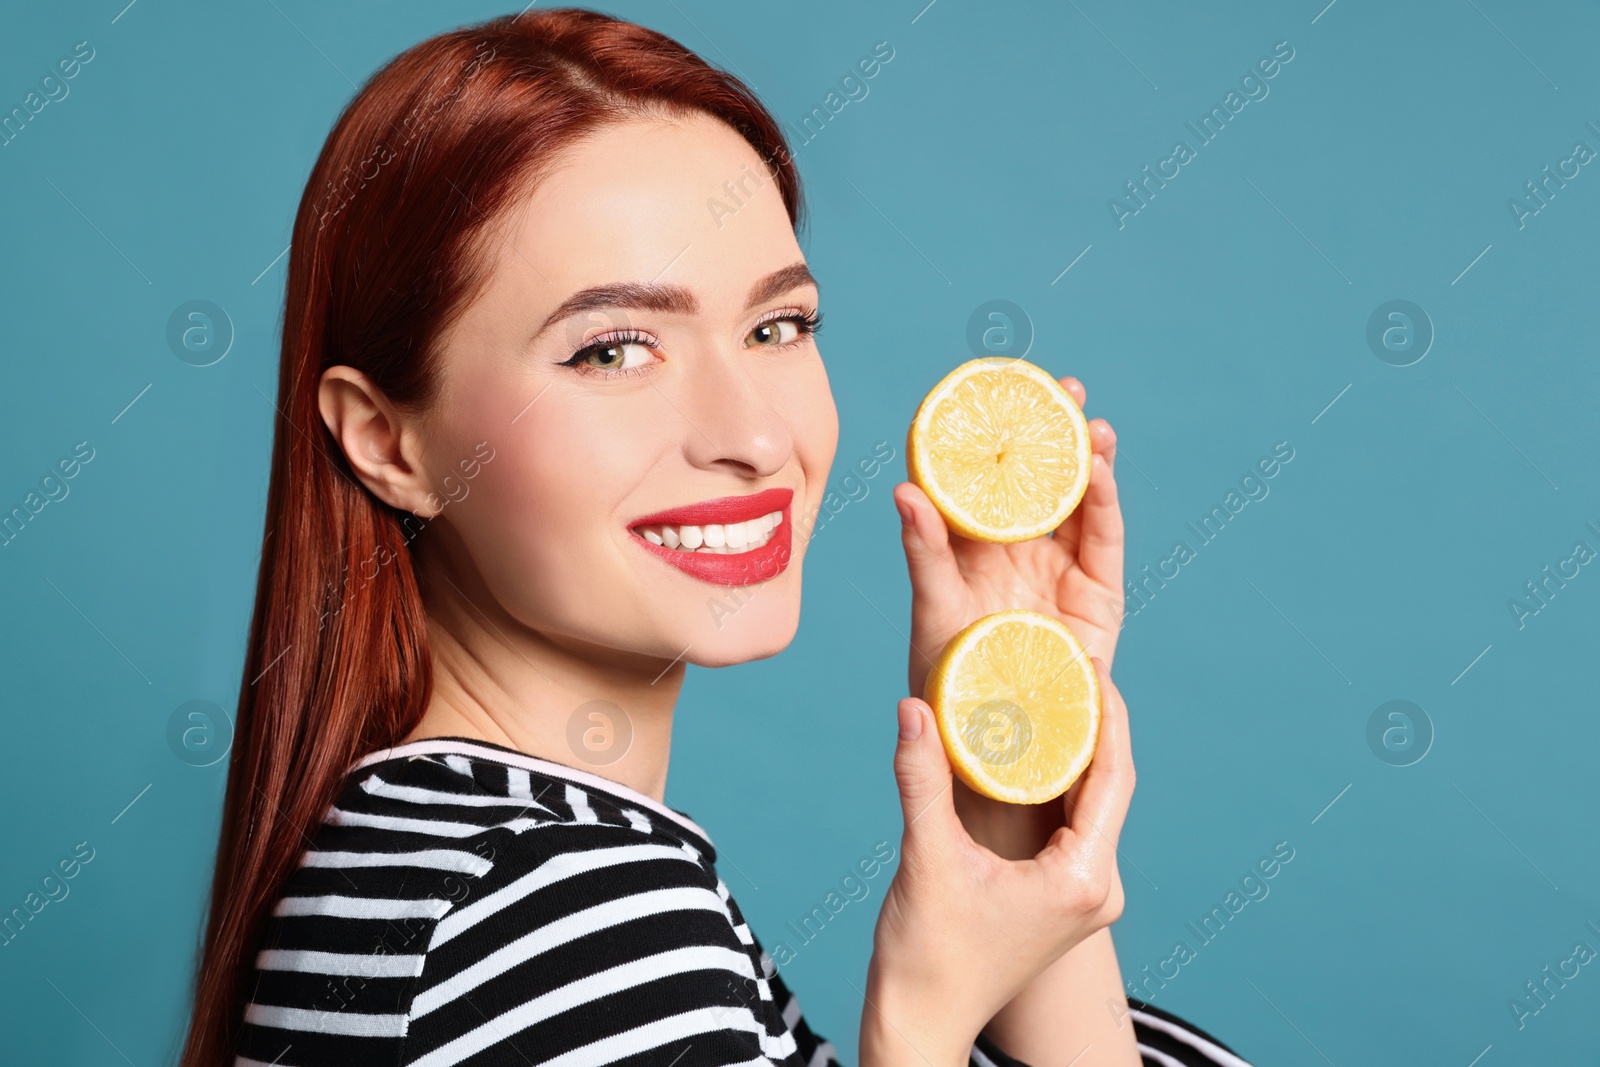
xmin=669 ymin=349 xmax=794 ymax=480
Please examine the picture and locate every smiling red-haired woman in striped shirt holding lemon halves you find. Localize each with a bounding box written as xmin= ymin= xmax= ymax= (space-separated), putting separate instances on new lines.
xmin=182 ymin=10 xmax=1243 ymax=1067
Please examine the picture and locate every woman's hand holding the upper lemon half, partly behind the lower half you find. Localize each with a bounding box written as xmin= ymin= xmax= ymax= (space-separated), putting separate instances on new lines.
xmin=894 ymin=378 xmax=1123 ymax=859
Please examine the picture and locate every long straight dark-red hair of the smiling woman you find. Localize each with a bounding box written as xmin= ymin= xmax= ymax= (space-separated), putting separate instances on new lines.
xmin=181 ymin=8 xmax=802 ymax=1067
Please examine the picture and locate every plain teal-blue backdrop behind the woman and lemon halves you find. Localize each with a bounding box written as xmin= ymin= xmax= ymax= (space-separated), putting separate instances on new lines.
xmin=0 ymin=0 xmax=1600 ymax=1067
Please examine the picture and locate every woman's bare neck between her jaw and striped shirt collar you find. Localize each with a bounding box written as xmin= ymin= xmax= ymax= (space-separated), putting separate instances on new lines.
xmin=402 ymin=534 xmax=685 ymax=803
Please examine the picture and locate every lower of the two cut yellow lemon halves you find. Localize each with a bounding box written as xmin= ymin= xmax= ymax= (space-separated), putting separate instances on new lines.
xmin=923 ymin=609 xmax=1101 ymax=805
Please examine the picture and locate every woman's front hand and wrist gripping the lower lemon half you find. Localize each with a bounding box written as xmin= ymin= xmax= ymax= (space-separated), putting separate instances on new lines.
xmin=861 ymin=657 xmax=1134 ymax=1067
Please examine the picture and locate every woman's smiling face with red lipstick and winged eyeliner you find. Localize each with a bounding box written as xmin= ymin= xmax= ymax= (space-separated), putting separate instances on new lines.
xmin=412 ymin=115 xmax=838 ymax=665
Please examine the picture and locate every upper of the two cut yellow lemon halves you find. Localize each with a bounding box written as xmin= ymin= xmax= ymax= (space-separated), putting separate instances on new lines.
xmin=906 ymin=355 xmax=1091 ymax=542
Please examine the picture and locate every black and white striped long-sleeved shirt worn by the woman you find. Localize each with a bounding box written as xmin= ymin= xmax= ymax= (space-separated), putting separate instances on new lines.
xmin=235 ymin=737 xmax=1248 ymax=1067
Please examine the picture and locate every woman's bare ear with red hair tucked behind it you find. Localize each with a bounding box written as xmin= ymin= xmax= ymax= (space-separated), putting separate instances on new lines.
xmin=317 ymin=366 xmax=443 ymax=518
